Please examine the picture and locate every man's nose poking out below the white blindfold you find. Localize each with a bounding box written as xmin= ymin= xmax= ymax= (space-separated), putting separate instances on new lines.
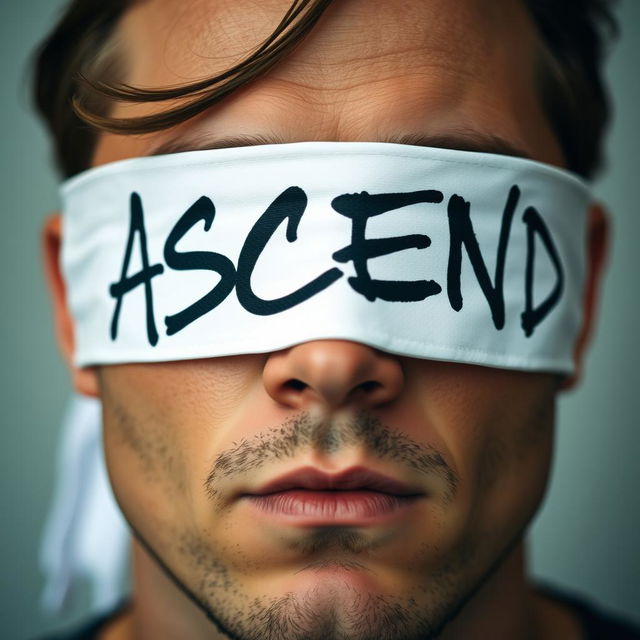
xmin=263 ymin=340 xmax=404 ymax=409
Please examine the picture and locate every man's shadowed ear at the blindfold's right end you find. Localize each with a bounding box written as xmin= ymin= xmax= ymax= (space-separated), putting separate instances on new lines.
xmin=561 ymin=203 xmax=610 ymax=390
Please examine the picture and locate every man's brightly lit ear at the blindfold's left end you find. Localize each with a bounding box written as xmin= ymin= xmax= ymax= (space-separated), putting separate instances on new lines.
xmin=42 ymin=214 xmax=98 ymax=397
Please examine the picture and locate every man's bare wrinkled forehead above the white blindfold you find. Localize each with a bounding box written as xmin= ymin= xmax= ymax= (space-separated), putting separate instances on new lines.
xmin=99 ymin=0 xmax=559 ymax=164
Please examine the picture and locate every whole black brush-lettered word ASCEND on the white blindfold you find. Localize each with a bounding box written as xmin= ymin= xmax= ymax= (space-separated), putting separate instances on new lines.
xmin=109 ymin=185 xmax=565 ymax=346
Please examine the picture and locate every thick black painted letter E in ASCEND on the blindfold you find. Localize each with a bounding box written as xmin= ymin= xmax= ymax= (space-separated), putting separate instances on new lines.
xmin=331 ymin=190 xmax=443 ymax=302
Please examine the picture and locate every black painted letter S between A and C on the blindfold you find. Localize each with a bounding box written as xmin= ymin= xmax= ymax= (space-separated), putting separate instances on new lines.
xmin=164 ymin=196 xmax=236 ymax=336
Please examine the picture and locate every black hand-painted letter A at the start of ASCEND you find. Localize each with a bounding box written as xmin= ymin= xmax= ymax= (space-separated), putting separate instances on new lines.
xmin=109 ymin=193 xmax=164 ymax=347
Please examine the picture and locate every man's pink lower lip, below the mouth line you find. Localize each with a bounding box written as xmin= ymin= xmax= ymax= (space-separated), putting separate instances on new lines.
xmin=248 ymin=489 xmax=419 ymax=525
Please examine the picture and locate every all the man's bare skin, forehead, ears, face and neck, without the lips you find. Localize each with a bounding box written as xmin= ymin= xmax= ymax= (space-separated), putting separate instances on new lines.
xmin=45 ymin=0 xmax=606 ymax=640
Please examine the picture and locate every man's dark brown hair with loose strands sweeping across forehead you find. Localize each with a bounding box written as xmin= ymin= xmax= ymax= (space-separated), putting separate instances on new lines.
xmin=34 ymin=0 xmax=616 ymax=177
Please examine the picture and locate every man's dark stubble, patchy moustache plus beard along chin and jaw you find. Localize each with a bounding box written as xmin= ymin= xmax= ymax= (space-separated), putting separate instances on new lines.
xmin=112 ymin=410 xmax=544 ymax=640
